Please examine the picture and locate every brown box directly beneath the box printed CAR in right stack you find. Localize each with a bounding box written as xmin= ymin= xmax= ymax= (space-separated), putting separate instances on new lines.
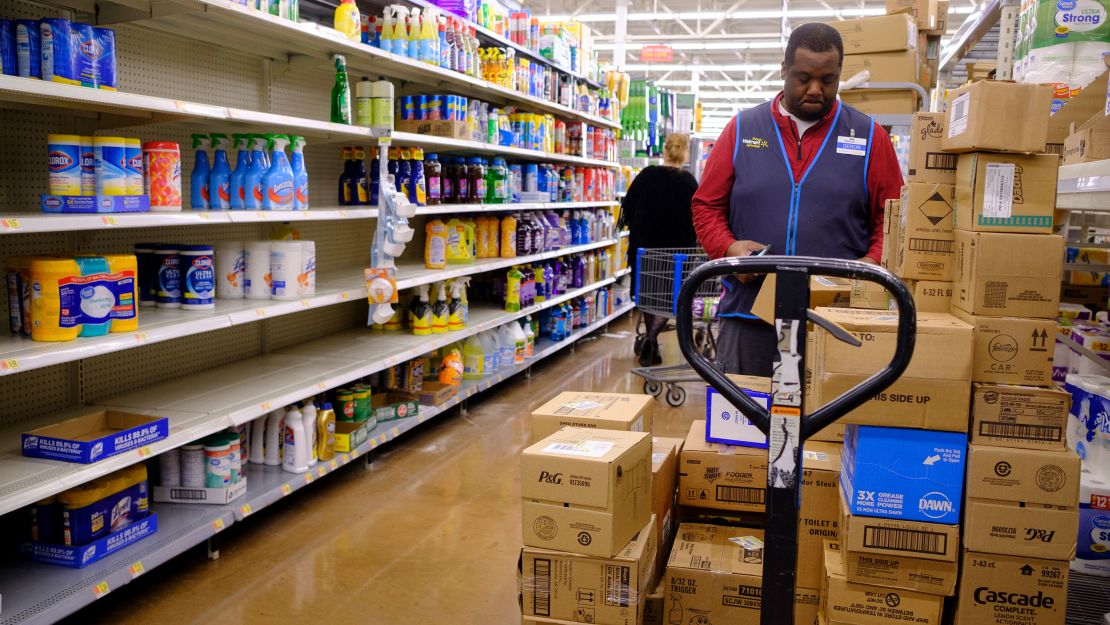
xmin=970 ymin=383 xmax=1071 ymax=451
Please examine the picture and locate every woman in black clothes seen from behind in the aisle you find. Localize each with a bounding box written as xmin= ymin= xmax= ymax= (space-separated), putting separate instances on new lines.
xmin=622 ymin=134 xmax=697 ymax=366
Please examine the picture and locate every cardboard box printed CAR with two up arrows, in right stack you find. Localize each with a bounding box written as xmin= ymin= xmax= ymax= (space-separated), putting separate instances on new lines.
xmin=952 ymin=309 xmax=1056 ymax=386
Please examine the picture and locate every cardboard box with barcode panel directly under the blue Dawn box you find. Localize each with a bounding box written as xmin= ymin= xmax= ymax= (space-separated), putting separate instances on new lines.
xmin=840 ymin=493 xmax=960 ymax=562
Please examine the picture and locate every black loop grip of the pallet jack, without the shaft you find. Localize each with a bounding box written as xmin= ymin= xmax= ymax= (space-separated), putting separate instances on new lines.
xmin=676 ymin=256 xmax=917 ymax=441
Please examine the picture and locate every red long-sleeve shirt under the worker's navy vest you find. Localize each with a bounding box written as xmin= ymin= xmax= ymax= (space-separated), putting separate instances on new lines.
xmin=690 ymin=93 xmax=902 ymax=263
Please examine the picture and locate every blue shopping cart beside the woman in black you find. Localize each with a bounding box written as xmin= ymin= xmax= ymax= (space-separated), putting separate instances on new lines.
xmin=632 ymin=248 xmax=720 ymax=406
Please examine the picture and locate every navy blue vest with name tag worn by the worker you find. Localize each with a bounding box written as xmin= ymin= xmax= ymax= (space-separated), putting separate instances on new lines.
xmin=719 ymin=101 xmax=875 ymax=319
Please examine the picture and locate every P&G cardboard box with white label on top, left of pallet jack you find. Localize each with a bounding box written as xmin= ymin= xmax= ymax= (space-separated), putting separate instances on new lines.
xmin=521 ymin=427 xmax=654 ymax=557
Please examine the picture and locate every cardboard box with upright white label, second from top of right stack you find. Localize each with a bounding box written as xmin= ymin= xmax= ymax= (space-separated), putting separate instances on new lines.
xmin=956 ymin=152 xmax=1060 ymax=234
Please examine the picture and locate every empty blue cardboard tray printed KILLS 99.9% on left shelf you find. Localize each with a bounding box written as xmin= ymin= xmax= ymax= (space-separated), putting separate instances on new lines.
xmin=23 ymin=410 xmax=170 ymax=464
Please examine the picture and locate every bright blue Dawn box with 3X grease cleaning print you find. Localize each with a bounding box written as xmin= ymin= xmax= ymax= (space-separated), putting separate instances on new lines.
xmin=840 ymin=425 xmax=968 ymax=525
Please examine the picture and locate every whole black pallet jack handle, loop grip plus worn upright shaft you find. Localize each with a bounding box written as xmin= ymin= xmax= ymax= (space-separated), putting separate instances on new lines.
xmin=677 ymin=256 xmax=917 ymax=625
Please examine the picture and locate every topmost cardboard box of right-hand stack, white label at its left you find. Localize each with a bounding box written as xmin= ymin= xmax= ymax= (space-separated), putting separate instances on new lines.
xmin=940 ymin=80 xmax=1052 ymax=152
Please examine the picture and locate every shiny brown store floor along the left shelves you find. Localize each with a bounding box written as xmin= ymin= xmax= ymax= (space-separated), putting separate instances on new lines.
xmin=65 ymin=317 xmax=705 ymax=625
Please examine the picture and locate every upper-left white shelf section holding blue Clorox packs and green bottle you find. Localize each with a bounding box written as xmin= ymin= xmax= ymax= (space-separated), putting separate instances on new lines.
xmin=0 ymin=75 xmax=375 ymax=143
